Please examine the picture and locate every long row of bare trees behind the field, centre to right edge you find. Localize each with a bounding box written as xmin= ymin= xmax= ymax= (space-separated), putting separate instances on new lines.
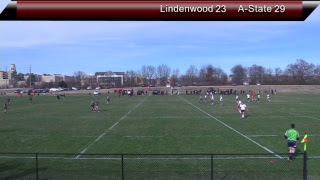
xmin=124 ymin=59 xmax=320 ymax=86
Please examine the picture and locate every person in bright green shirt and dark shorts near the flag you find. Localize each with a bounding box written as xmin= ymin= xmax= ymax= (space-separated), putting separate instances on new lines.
xmin=284 ymin=124 xmax=300 ymax=161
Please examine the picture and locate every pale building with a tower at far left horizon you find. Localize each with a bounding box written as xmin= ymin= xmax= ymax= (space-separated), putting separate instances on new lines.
xmin=0 ymin=64 xmax=17 ymax=88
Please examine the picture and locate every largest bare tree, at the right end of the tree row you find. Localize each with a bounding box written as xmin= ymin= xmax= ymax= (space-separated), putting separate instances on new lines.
xmin=286 ymin=59 xmax=315 ymax=85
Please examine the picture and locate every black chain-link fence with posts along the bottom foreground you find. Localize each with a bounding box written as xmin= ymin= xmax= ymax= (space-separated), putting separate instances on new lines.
xmin=0 ymin=153 xmax=307 ymax=180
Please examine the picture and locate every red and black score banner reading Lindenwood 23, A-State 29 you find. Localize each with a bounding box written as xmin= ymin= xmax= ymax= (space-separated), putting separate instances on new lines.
xmin=0 ymin=0 xmax=320 ymax=21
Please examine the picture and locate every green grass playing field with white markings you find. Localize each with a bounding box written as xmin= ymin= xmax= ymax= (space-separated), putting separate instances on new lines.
xmin=0 ymin=93 xmax=320 ymax=179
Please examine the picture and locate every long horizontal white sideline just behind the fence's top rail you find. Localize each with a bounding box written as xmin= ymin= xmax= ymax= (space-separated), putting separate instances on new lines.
xmin=0 ymin=154 xmax=320 ymax=161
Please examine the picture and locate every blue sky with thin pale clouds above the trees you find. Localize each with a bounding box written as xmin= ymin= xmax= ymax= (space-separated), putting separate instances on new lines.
xmin=0 ymin=1 xmax=320 ymax=75
